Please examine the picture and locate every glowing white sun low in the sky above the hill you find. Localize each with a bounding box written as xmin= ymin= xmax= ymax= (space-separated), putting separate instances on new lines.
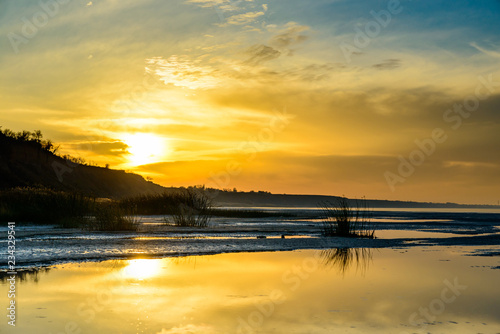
xmin=124 ymin=133 xmax=166 ymax=166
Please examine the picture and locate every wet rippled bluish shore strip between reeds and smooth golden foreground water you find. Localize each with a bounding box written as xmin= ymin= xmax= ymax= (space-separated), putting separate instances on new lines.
xmin=0 ymin=216 xmax=500 ymax=272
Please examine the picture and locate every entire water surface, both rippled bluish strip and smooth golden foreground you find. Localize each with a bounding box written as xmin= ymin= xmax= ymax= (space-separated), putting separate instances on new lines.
xmin=0 ymin=208 xmax=500 ymax=334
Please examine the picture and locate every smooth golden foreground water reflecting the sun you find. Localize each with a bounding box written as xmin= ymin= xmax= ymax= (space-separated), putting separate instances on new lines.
xmin=0 ymin=247 xmax=500 ymax=334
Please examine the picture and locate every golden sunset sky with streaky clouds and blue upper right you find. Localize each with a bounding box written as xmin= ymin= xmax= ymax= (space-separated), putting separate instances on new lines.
xmin=0 ymin=0 xmax=500 ymax=204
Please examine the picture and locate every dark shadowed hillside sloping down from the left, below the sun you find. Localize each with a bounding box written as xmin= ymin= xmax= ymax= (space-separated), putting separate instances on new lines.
xmin=0 ymin=130 xmax=165 ymax=199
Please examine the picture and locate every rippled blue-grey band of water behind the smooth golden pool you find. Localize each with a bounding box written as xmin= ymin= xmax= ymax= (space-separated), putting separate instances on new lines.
xmin=0 ymin=208 xmax=500 ymax=269
